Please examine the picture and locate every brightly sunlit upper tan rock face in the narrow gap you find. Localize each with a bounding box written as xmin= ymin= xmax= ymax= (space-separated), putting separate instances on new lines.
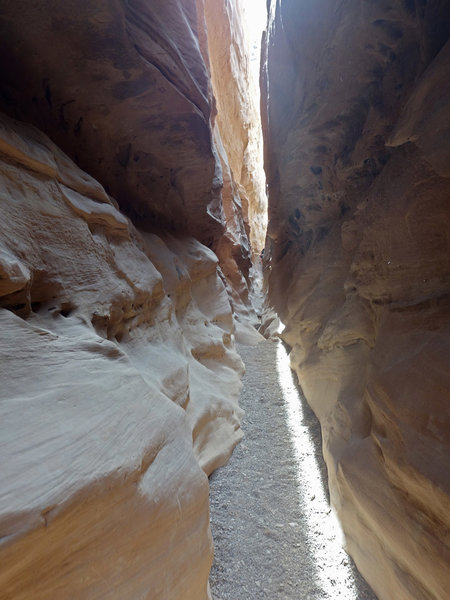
xmin=204 ymin=0 xmax=267 ymax=253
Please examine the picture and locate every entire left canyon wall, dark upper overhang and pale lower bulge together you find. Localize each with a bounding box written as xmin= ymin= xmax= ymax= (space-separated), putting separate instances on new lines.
xmin=0 ymin=0 xmax=266 ymax=600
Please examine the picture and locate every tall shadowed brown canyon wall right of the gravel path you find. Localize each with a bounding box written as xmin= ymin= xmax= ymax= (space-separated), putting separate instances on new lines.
xmin=263 ymin=0 xmax=450 ymax=600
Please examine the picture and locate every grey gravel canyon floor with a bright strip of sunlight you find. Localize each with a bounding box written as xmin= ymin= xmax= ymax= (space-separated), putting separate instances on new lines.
xmin=210 ymin=340 xmax=375 ymax=600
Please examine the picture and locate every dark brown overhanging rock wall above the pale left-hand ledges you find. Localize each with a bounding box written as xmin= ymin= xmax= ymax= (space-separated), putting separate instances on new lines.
xmin=0 ymin=0 xmax=219 ymax=241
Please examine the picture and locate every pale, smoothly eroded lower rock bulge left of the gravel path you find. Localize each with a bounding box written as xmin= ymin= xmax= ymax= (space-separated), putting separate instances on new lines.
xmin=0 ymin=111 xmax=242 ymax=600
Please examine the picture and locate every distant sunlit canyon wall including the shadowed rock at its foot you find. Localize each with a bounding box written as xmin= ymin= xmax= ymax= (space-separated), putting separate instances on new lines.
xmin=204 ymin=0 xmax=267 ymax=327
